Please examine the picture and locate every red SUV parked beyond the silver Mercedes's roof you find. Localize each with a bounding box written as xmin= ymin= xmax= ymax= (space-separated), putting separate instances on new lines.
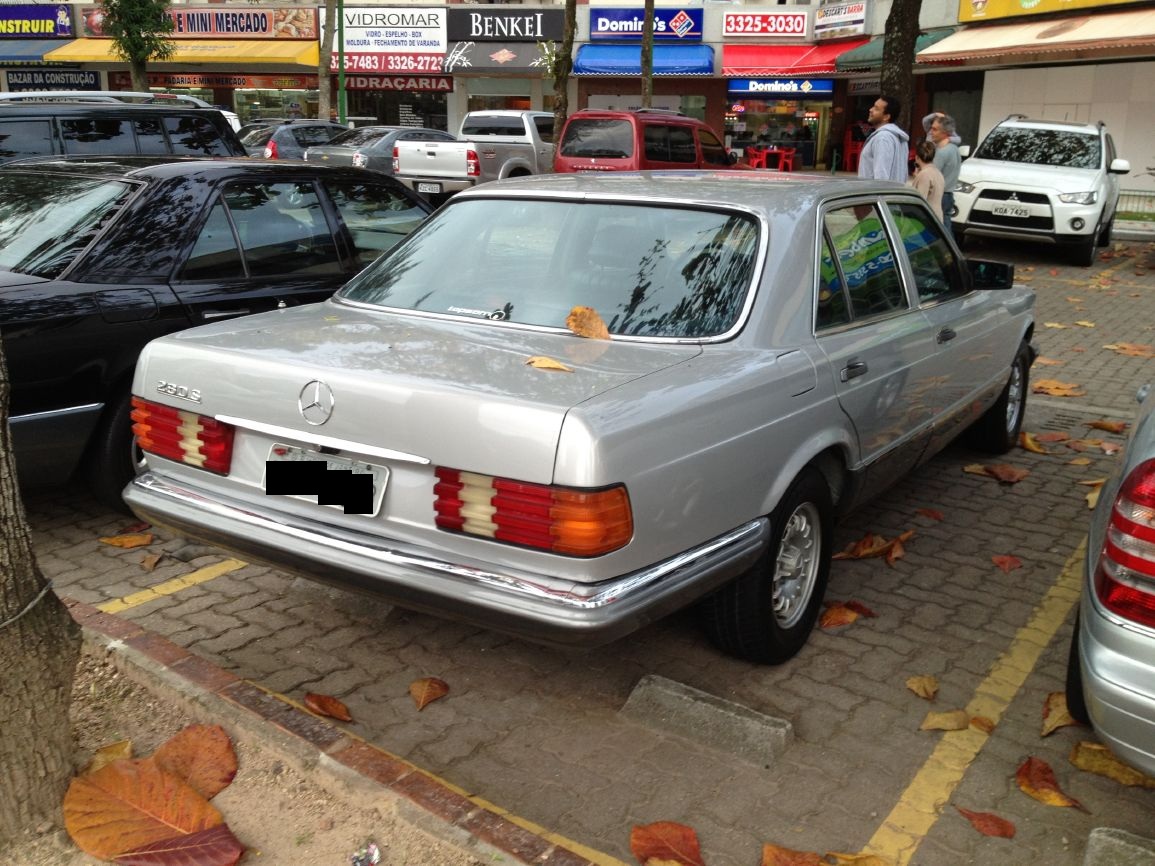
xmin=553 ymin=109 xmax=737 ymax=172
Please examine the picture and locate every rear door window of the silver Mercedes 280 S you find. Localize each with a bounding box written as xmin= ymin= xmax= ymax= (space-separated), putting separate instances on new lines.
xmin=824 ymin=204 xmax=908 ymax=319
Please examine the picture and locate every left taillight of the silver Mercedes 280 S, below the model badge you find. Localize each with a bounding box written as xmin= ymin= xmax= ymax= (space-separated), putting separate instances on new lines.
xmin=132 ymin=397 xmax=237 ymax=475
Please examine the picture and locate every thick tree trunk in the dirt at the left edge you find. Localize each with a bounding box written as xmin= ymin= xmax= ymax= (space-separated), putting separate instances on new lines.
xmin=0 ymin=341 xmax=80 ymax=843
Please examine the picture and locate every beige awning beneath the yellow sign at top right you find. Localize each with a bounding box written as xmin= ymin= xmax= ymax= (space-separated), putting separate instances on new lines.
xmin=916 ymin=9 xmax=1155 ymax=66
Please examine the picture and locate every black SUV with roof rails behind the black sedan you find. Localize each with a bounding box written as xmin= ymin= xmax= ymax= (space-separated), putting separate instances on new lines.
xmin=0 ymin=102 xmax=245 ymax=163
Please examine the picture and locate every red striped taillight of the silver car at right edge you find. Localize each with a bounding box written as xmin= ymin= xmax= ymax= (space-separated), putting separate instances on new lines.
xmin=1095 ymin=460 xmax=1155 ymax=628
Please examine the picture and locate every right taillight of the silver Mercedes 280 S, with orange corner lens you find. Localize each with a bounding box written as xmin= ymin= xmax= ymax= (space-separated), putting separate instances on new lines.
xmin=433 ymin=466 xmax=634 ymax=557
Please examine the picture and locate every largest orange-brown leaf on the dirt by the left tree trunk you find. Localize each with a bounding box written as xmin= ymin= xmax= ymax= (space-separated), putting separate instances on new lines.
xmin=64 ymin=761 xmax=223 ymax=860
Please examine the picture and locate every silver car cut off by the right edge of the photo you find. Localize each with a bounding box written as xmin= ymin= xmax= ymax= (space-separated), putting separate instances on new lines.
xmin=1067 ymin=388 xmax=1155 ymax=776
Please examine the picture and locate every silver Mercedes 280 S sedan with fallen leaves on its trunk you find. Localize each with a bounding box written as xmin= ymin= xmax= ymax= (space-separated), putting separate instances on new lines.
xmin=125 ymin=171 xmax=1035 ymax=663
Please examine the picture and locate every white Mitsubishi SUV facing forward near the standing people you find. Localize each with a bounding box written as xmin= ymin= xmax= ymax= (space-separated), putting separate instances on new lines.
xmin=952 ymin=114 xmax=1131 ymax=266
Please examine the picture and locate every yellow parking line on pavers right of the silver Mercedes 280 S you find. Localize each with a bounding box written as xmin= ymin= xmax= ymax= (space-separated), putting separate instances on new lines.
xmin=864 ymin=538 xmax=1087 ymax=866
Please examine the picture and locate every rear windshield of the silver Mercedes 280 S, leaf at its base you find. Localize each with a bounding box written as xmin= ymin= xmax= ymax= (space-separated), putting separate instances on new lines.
xmin=338 ymin=199 xmax=759 ymax=338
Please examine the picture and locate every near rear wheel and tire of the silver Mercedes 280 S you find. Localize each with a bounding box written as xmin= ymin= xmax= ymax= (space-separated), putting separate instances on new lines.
xmin=702 ymin=468 xmax=834 ymax=664
